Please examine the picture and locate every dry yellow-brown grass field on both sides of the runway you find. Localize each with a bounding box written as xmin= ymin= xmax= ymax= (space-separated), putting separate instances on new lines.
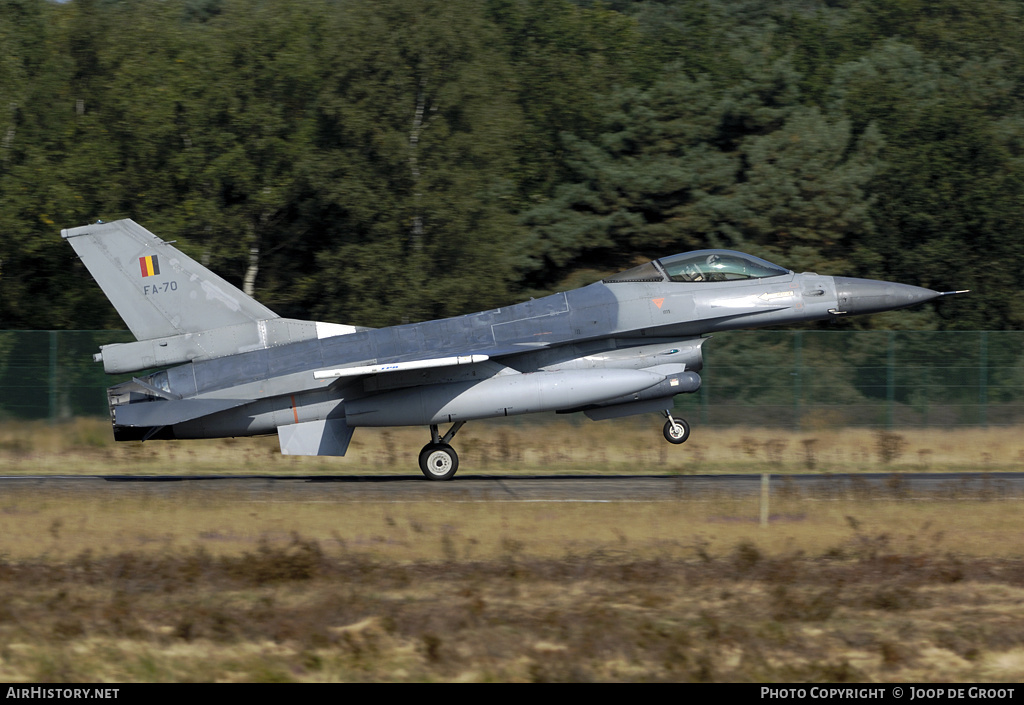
xmin=0 ymin=422 xmax=1024 ymax=682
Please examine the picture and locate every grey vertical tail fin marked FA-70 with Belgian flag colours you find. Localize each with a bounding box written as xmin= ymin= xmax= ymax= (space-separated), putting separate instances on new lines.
xmin=60 ymin=219 xmax=278 ymax=340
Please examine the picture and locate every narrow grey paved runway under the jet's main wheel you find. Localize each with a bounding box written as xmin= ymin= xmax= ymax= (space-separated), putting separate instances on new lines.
xmin=0 ymin=472 xmax=1024 ymax=502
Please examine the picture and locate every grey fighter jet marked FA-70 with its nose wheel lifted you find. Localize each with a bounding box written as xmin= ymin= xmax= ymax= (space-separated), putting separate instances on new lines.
xmin=60 ymin=219 xmax=961 ymax=481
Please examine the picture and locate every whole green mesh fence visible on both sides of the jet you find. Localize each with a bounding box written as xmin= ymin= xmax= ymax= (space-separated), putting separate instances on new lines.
xmin=0 ymin=331 xmax=1024 ymax=430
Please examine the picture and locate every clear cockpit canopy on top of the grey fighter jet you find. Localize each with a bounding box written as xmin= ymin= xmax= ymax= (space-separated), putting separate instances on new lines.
xmin=603 ymin=250 xmax=790 ymax=284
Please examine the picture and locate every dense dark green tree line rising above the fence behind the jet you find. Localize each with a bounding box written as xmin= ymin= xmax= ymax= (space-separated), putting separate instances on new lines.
xmin=0 ymin=0 xmax=1024 ymax=329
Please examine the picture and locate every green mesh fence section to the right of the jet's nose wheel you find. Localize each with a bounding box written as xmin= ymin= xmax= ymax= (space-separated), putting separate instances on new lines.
xmin=676 ymin=331 xmax=1024 ymax=429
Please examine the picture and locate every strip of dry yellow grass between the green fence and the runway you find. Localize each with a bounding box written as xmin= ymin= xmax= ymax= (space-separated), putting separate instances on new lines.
xmin=0 ymin=415 xmax=1024 ymax=474
